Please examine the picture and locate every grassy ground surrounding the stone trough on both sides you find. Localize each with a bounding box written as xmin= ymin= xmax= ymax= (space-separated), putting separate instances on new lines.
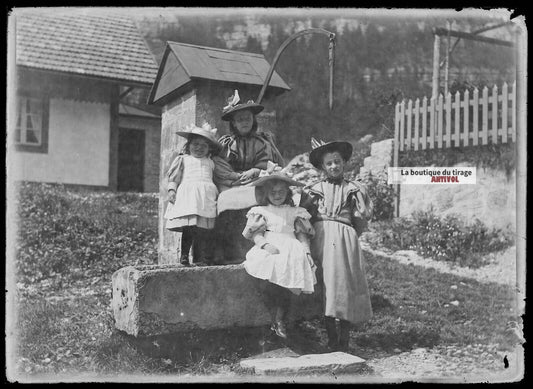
xmin=8 ymin=184 xmax=520 ymax=379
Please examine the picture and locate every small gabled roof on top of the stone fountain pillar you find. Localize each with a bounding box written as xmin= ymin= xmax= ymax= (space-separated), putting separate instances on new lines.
xmin=148 ymin=42 xmax=291 ymax=104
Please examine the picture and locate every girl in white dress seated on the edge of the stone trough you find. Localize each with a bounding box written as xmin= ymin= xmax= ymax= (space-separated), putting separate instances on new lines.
xmin=243 ymin=172 xmax=317 ymax=338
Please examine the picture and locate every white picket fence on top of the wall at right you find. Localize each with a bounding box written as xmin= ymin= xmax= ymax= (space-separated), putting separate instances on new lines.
xmin=394 ymin=81 xmax=516 ymax=151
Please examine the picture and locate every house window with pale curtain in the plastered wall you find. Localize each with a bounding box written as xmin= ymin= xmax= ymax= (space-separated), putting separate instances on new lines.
xmin=15 ymin=95 xmax=49 ymax=153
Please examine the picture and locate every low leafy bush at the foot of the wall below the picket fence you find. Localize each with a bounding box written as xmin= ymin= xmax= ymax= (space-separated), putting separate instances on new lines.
xmin=366 ymin=211 xmax=513 ymax=267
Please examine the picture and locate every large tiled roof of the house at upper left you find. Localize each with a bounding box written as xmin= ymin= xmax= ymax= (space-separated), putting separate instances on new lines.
xmin=15 ymin=9 xmax=157 ymax=84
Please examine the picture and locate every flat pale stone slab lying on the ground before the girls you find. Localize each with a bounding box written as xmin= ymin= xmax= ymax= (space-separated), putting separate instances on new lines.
xmin=240 ymin=352 xmax=365 ymax=375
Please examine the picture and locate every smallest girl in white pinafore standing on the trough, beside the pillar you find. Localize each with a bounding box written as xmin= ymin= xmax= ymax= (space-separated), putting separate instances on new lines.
xmin=164 ymin=124 xmax=221 ymax=266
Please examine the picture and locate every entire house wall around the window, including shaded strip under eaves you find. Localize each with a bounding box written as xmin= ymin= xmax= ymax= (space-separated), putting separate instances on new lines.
xmin=10 ymin=68 xmax=116 ymax=186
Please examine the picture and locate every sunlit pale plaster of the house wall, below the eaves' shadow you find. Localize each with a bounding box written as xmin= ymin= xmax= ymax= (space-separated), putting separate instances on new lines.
xmin=13 ymin=98 xmax=110 ymax=186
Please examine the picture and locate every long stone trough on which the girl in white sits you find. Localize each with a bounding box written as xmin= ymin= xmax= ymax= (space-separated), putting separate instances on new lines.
xmin=112 ymin=264 xmax=322 ymax=336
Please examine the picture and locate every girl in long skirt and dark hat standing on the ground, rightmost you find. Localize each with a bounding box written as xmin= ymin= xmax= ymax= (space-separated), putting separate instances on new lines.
xmin=300 ymin=139 xmax=373 ymax=351
